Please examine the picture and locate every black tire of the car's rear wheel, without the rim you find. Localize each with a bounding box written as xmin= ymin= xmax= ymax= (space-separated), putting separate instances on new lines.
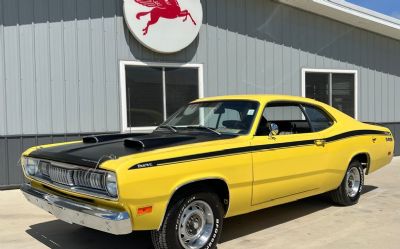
xmin=329 ymin=160 xmax=364 ymax=206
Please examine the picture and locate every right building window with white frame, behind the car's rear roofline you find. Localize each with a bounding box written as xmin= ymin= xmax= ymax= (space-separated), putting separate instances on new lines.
xmin=302 ymin=69 xmax=357 ymax=118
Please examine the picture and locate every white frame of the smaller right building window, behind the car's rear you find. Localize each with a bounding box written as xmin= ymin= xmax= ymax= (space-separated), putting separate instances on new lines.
xmin=301 ymin=68 xmax=358 ymax=119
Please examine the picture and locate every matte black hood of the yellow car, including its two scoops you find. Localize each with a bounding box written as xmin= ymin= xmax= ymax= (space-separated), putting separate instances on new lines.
xmin=29 ymin=132 xmax=236 ymax=168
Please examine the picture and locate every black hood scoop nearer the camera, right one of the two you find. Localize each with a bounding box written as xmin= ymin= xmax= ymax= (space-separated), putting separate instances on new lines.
xmin=124 ymin=136 xmax=196 ymax=150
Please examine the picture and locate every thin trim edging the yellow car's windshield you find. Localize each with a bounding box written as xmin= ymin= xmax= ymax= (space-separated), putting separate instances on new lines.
xmin=160 ymin=99 xmax=260 ymax=136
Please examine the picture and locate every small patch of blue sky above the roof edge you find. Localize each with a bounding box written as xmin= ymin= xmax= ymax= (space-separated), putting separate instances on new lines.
xmin=347 ymin=0 xmax=400 ymax=19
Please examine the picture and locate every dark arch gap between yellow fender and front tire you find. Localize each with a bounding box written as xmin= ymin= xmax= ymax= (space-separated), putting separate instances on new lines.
xmin=159 ymin=177 xmax=230 ymax=229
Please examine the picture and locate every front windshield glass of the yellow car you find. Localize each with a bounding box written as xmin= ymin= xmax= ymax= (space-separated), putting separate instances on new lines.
xmin=160 ymin=100 xmax=258 ymax=135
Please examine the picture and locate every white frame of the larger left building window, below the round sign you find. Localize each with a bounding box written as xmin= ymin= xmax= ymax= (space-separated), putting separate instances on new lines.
xmin=119 ymin=60 xmax=204 ymax=132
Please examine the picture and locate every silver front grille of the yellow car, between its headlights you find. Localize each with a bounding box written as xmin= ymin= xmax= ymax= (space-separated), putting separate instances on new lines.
xmin=39 ymin=161 xmax=106 ymax=192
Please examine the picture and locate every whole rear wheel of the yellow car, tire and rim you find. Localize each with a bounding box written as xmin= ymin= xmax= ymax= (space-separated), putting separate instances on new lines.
xmin=330 ymin=161 xmax=364 ymax=206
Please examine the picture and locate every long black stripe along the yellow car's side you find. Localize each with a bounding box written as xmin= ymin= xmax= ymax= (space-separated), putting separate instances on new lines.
xmin=129 ymin=130 xmax=389 ymax=169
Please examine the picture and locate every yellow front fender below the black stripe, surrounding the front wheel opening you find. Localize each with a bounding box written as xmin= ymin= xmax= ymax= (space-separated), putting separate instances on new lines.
xmin=117 ymin=153 xmax=253 ymax=230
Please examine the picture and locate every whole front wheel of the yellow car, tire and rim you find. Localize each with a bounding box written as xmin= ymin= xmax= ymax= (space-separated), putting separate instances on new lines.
xmin=151 ymin=192 xmax=224 ymax=249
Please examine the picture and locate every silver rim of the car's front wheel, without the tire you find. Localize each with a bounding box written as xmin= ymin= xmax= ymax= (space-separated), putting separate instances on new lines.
xmin=178 ymin=200 xmax=214 ymax=249
